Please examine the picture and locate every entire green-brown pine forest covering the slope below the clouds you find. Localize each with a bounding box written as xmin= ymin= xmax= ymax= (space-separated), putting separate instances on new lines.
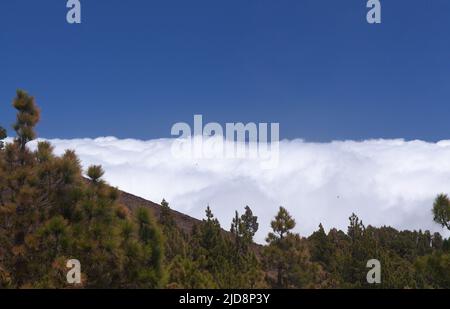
xmin=0 ymin=90 xmax=450 ymax=289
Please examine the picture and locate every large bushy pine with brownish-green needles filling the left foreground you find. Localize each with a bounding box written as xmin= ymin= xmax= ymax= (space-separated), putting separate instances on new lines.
xmin=0 ymin=92 xmax=164 ymax=288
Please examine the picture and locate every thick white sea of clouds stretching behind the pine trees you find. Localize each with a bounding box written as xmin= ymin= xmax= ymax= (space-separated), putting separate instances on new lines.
xmin=24 ymin=137 xmax=450 ymax=243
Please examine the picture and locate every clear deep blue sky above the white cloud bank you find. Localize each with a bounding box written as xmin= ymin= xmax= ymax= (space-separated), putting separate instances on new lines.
xmin=0 ymin=0 xmax=450 ymax=141
